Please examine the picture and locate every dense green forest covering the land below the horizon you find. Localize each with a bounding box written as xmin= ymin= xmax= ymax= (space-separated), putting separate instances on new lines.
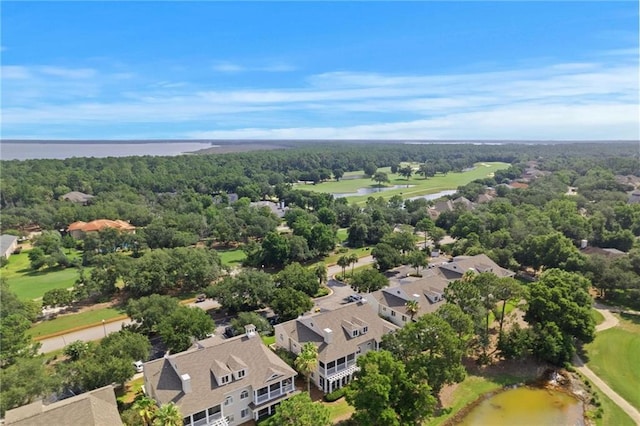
xmin=0 ymin=143 xmax=640 ymax=422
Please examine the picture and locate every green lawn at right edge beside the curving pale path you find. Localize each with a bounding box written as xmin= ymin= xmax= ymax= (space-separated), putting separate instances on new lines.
xmin=585 ymin=319 xmax=640 ymax=409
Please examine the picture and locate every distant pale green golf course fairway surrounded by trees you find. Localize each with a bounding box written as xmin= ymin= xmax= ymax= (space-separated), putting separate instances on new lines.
xmin=299 ymin=162 xmax=509 ymax=203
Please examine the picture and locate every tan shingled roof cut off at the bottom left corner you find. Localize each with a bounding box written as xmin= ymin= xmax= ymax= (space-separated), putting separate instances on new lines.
xmin=4 ymin=385 xmax=122 ymax=426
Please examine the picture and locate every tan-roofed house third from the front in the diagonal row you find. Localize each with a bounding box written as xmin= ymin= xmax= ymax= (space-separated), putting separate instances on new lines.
xmin=366 ymin=269 xmax=449 ymax=327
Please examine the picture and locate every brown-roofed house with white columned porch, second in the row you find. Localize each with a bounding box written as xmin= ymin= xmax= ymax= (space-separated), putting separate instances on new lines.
xmin=274 ymin=300 xmax=397 ymax=393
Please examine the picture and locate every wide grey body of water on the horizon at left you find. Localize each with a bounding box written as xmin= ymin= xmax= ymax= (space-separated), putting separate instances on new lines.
xmin=0 ymin=142 xmax=215 ymax=160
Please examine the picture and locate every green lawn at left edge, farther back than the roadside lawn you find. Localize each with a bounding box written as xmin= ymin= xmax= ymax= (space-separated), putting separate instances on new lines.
xmin=2 ymin=250 xmax=85 ymax=300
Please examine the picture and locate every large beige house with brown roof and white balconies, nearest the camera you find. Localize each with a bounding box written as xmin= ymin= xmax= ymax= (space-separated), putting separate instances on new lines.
xmin=144 ymin=325 xmax=297 ymax=426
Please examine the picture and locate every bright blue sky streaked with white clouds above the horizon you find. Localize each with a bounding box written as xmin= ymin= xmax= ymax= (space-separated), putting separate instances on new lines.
xmin=0 ymin=1 xmax=640 ymax=140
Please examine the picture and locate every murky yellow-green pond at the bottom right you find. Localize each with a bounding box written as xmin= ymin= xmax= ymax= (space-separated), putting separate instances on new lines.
xmin=457 ymin=386 xmax=584 ymax=426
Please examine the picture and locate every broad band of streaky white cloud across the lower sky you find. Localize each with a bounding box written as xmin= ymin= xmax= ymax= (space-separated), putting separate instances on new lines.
xmin=2 ymin=52 xmax=640 ymax=139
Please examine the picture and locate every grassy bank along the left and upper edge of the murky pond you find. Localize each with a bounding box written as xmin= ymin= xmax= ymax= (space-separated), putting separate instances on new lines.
xmin=424 ymin=374 xmax=531 ymax=426
